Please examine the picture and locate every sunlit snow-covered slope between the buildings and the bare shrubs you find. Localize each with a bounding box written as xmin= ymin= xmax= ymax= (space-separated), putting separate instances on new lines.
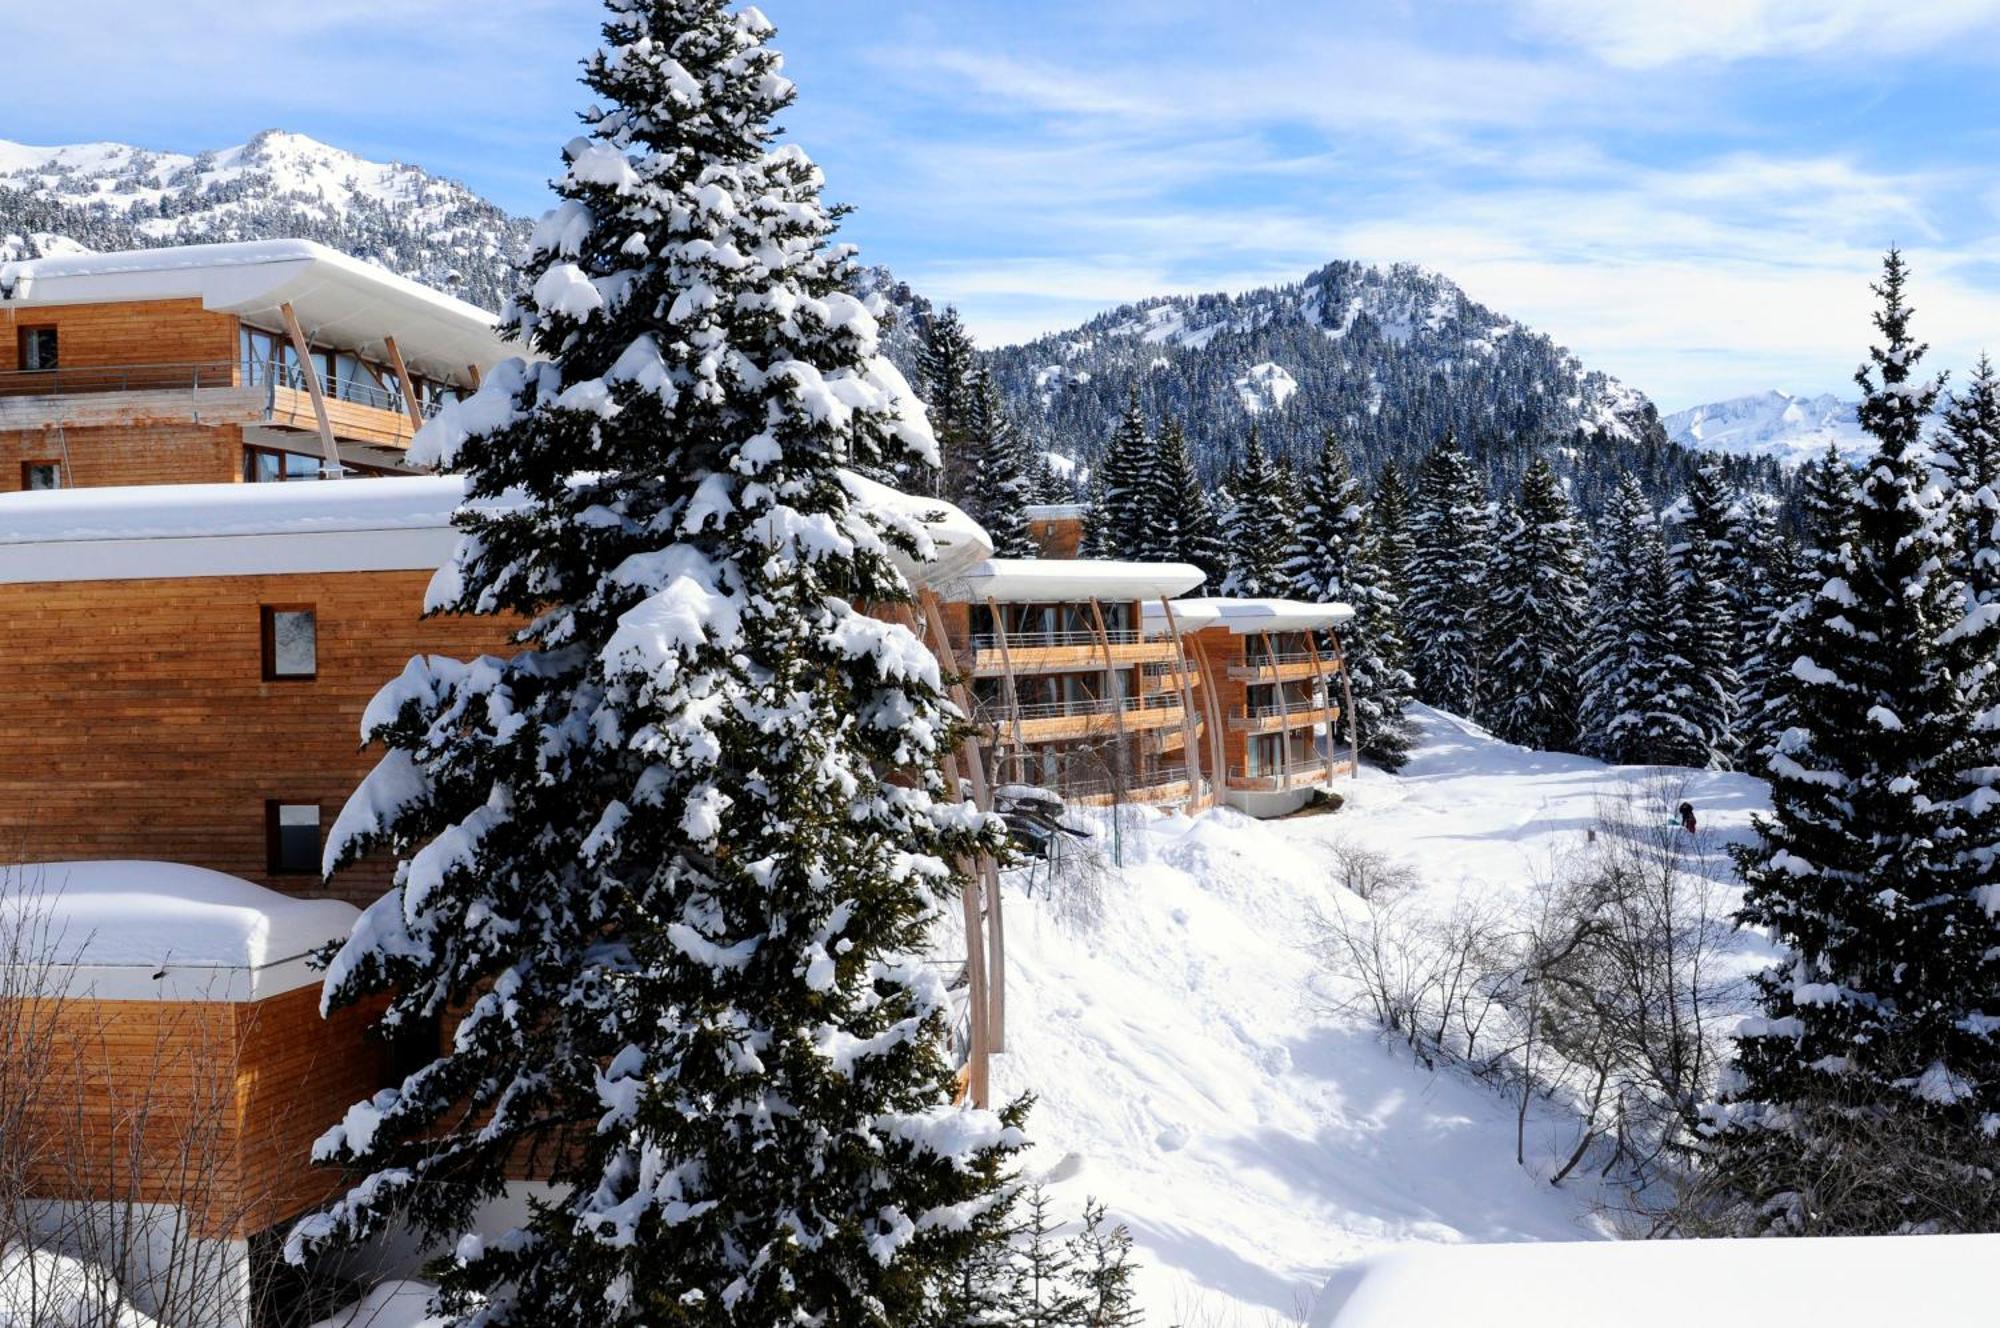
xmin=996 ymin=712 xmax=1764 ymax=1328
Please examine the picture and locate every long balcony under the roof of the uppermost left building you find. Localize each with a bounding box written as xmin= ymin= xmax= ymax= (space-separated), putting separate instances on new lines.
xmin=0 ymin=360 xmax=438 ymax=446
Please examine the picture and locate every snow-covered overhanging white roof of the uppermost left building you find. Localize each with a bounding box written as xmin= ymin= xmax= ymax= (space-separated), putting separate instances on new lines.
xmin=0 ymin=240 xmax=514 ymax=382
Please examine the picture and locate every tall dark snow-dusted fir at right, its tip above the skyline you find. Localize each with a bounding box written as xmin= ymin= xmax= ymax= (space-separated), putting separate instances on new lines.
xmin=1714 ymin=252 xmax=2000 ymax=1234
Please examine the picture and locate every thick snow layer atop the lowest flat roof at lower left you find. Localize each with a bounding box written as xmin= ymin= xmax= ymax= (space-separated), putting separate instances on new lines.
xmin=0 ymin=862 xmax=360 ymax=970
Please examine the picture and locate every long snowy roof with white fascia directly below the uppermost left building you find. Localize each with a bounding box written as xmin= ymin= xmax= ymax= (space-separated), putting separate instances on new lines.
xmin=0 ymin=476 xmax=466 ymax=584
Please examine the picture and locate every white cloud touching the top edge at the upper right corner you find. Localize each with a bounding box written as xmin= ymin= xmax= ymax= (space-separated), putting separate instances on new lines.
xmin=1520 ymin=0 xmax=2000 ymax=68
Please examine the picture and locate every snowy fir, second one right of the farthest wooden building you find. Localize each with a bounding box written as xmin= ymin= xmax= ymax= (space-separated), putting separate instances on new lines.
xmin=1402 ymin=438 xmax=1494 ymax=718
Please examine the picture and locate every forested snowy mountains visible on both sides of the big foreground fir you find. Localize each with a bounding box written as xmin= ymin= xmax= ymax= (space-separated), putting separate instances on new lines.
xmin=0 ymin=130 xmax=1778 ymax=508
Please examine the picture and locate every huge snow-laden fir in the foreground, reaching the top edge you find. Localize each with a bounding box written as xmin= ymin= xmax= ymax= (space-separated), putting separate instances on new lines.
xmin=288 ymin=0 xmax=1024 ymax=1328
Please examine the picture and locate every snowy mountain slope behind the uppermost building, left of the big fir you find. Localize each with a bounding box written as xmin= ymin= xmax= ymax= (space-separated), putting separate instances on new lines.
xmin=0 ymin=130 xmax=526 ymax=308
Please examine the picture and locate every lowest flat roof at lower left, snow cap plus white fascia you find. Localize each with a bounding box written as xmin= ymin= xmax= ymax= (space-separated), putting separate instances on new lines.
xmin=0 ymin=862 xmax=360 ymax=1000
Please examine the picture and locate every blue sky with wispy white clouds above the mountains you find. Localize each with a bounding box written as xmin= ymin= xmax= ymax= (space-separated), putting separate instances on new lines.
xmin=0 ymin=0 xmax=2000 ymax=410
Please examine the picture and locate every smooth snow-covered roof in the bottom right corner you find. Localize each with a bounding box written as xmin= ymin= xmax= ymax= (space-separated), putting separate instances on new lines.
xmin=1310 ymin=1236 xmax=2000 ymax=1328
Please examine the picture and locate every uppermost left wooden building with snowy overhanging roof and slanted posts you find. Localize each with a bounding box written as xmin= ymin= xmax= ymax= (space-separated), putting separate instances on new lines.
xmin=0 ymin=240 xmax=506 ymax=492
